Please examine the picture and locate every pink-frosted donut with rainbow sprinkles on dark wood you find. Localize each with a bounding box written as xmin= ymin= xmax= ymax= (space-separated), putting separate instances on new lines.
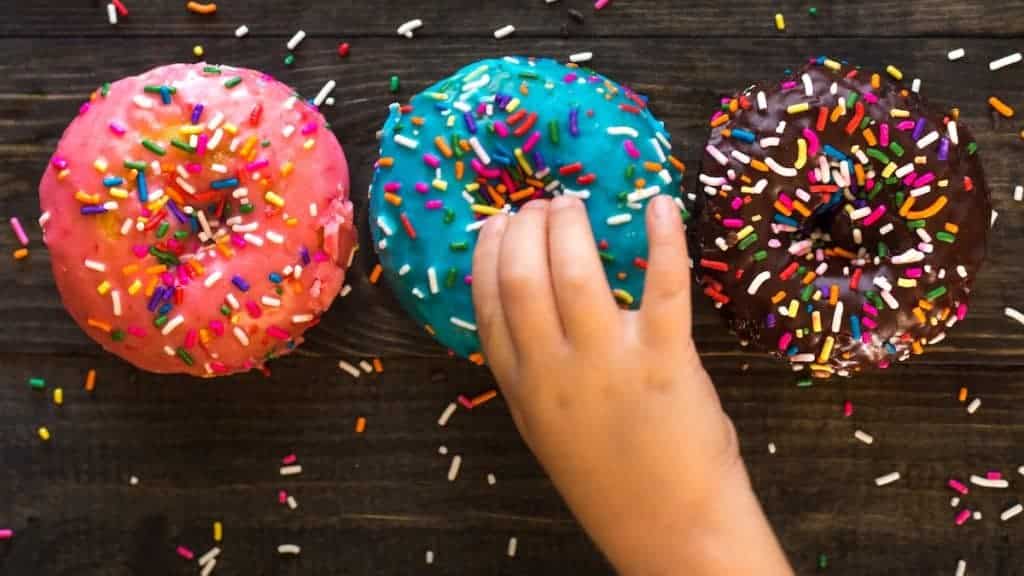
xmin=39 ymin=64 xmax=356 ymax=376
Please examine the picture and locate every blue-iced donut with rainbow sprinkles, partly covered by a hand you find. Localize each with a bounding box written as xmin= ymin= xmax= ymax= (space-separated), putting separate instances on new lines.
xmin=370 ymin=54 xmax=682 ymax=357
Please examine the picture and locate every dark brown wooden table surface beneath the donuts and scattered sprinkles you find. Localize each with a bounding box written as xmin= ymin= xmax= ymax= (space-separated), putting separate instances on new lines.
xmin=0 ymin=0 xmax=1024 ymax=576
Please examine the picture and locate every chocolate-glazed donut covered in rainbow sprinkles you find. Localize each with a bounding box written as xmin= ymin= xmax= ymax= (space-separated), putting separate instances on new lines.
xmin=694 ymin=57 xmax=992 ymax=377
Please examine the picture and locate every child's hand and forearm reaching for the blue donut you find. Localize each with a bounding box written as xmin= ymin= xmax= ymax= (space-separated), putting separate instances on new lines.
xmin=473 ymin=197 xmax=788 ymax=576
